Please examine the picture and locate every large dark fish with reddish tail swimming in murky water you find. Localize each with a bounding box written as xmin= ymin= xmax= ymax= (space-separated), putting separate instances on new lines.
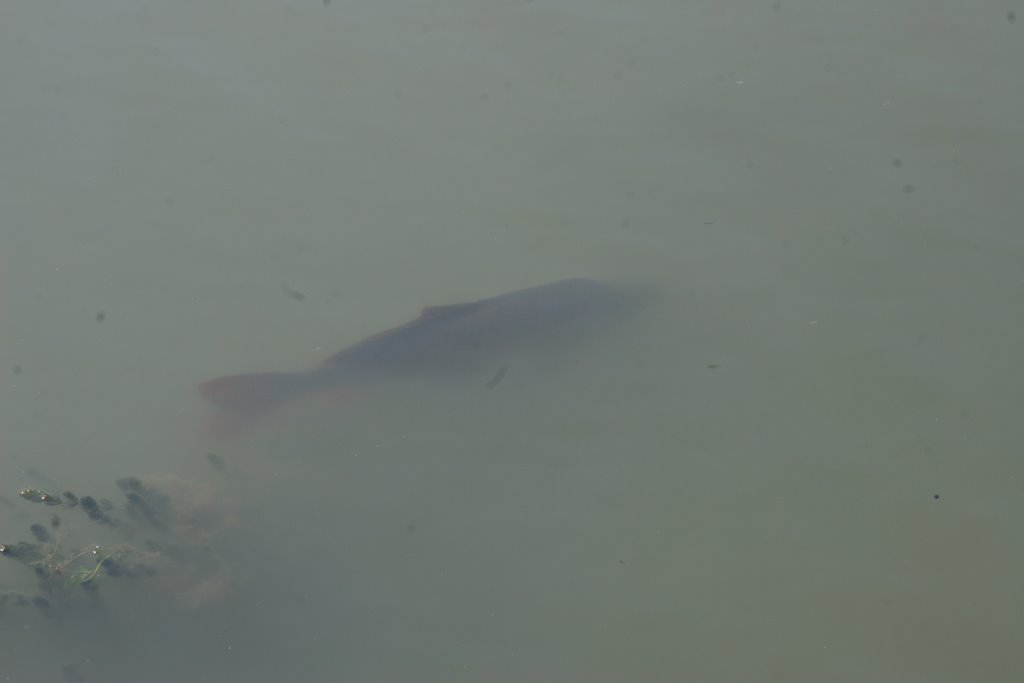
xmin=199 ymin=278 xmax=653 ymax=436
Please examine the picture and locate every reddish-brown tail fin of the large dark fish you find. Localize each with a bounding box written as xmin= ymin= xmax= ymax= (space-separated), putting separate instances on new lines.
xmin=199 ymin=373 xmax=303 ymax=437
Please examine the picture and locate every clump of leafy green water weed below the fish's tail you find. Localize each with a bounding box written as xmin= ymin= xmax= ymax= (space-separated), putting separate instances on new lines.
xmin=0 ymin=476 xmax=229 ymax=616
